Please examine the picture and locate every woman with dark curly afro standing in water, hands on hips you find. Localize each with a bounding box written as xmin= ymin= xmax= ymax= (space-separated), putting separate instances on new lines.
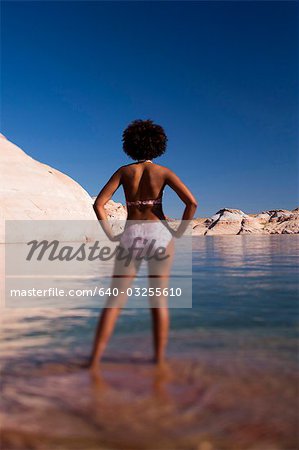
xmin=90 ymin=120 xmax=197 ymax=370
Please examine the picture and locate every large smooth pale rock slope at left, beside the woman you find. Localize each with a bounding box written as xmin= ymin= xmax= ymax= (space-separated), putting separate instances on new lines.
xmin=0 ymin=135 xmax=125 ymax=243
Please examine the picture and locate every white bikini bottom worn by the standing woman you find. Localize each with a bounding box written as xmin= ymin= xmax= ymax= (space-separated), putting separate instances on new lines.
xmin=120 ymin=220 xmax=172 ymax=255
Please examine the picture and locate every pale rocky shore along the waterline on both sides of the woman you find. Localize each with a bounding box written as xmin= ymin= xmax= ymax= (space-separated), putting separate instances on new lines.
xmin=0 ymin=134 xmax=299 ymax=243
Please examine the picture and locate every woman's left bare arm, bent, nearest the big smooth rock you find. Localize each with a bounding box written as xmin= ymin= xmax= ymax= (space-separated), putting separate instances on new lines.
xmin=93 ymin=168 xmax=122 ymax=240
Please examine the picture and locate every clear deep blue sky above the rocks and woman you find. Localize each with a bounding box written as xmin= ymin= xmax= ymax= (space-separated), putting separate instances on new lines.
xmin=1 ymin=1 xmax=298 ymax=217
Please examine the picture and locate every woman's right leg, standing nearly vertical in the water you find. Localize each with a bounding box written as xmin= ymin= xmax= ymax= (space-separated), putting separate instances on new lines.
xmin=148 ymin=240 xmax=174 ymax=364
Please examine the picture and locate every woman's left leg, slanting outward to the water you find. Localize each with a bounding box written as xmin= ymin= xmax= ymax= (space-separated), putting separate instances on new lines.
xmin=90 ymin=253 xmax=138 ymax=370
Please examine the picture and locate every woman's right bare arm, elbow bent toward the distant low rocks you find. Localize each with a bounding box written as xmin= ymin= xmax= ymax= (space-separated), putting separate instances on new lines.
xmin=165 ymin=169 xmax=197 ymax=237
